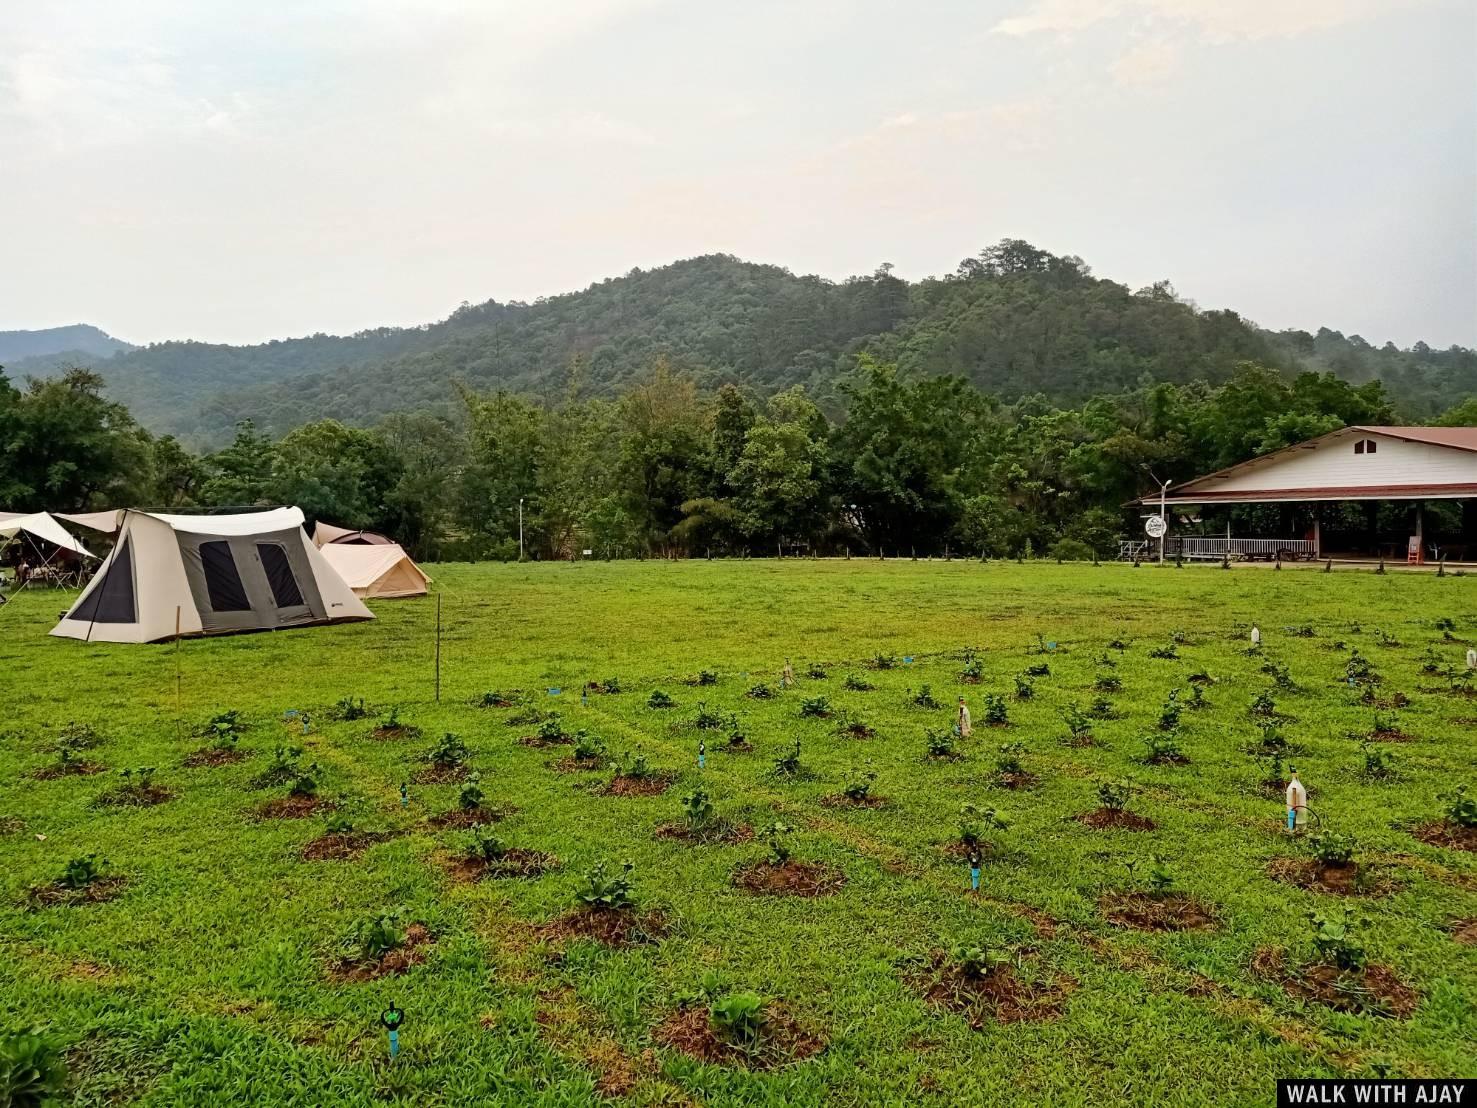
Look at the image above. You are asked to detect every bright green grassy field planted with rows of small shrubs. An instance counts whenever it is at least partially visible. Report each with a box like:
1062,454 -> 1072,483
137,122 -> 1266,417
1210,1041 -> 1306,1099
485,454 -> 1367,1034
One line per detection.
0,560 -> 1477,1105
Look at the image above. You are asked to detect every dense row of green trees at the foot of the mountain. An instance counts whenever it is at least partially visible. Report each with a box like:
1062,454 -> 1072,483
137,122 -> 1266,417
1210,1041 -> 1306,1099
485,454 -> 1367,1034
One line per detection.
0,353 -> 1477,560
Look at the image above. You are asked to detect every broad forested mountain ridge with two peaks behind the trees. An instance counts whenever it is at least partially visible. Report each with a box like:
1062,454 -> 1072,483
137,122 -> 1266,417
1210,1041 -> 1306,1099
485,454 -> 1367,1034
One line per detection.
9,239 -> 1477,445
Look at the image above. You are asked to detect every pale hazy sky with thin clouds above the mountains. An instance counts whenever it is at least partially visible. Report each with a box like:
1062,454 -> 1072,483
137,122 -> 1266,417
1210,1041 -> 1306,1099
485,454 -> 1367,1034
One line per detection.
0,0 -> 1477,346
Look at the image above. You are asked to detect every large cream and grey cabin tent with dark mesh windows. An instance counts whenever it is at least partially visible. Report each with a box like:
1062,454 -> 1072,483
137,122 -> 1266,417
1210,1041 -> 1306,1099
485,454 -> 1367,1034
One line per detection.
52,508 -> 374,643
